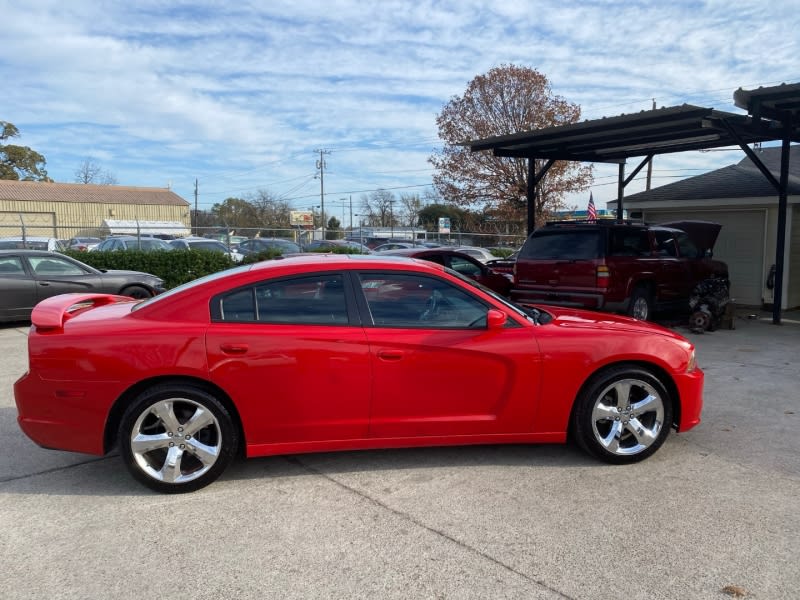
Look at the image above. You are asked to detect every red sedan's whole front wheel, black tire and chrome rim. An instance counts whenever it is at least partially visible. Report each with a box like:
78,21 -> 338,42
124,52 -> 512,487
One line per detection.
572,365 -> 672,464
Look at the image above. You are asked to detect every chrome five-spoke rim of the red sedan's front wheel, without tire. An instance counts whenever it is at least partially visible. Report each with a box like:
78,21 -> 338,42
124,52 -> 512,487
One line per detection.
591,379 -> 664,456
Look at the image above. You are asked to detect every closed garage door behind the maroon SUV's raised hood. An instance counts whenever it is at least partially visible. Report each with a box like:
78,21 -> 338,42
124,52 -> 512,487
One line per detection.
644,210 -> 766,306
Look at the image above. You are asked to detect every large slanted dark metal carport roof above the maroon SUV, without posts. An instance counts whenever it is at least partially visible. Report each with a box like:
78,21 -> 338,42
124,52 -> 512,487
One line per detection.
466,104 -> 800,163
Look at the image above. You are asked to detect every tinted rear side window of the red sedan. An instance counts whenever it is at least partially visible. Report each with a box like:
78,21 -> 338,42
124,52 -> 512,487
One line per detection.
212,274 -> 349,325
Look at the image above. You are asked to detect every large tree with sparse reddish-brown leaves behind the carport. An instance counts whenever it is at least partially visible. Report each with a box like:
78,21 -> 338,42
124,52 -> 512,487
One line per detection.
429,65 -> 592,227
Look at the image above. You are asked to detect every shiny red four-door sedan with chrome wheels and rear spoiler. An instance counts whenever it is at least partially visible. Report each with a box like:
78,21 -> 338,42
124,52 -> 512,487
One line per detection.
14,255 -> 703,492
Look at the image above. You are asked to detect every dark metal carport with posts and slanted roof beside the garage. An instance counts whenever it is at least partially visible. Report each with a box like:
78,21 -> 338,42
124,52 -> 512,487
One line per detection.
466,83 -> 800,324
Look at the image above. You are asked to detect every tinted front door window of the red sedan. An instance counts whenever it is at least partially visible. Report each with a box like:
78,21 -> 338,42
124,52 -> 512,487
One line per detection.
360,273 -> 487,329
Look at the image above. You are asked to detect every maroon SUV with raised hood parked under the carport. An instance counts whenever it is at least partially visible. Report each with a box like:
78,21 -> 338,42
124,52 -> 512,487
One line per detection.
511,220 -> 728,320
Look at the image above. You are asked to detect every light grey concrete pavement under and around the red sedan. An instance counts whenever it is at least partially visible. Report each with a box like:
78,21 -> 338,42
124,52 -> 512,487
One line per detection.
0,312 -> 800,600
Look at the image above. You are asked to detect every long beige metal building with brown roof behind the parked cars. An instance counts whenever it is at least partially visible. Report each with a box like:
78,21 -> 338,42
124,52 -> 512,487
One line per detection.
0,180 -> 191,239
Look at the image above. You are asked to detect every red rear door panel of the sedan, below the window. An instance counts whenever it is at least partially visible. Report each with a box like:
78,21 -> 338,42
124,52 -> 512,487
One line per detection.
207,323 -> 370,444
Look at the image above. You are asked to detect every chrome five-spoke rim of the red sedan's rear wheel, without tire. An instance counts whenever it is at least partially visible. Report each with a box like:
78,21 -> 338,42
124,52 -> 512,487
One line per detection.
129,398 -> 222,484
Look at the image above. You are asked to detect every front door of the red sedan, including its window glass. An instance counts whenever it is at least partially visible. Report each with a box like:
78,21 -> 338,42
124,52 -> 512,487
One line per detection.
360,272 -> 540,437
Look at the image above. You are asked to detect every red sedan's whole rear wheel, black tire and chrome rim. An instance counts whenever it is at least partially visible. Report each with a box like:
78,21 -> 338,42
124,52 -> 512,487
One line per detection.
118,384 -> 239,494
